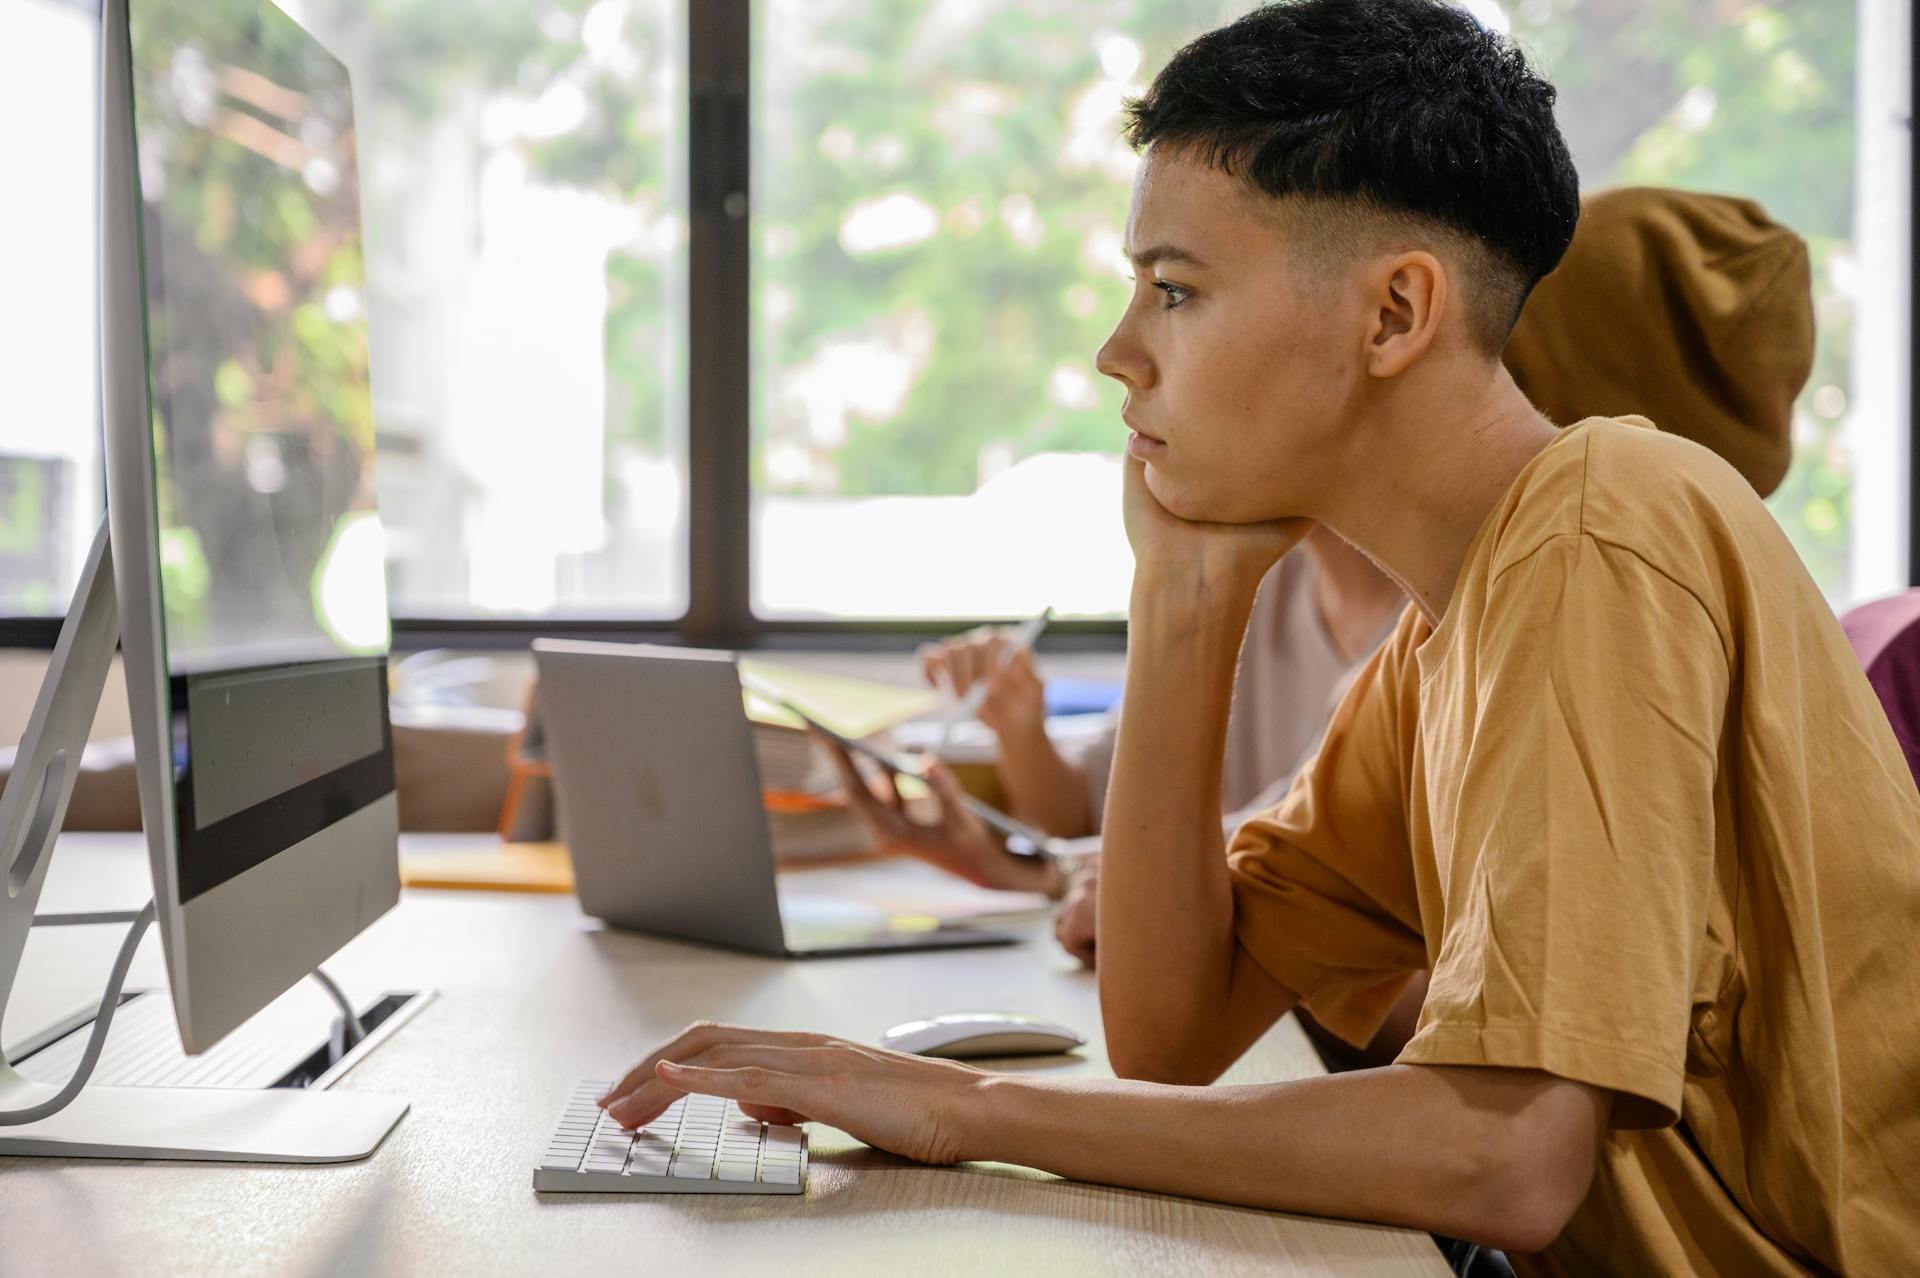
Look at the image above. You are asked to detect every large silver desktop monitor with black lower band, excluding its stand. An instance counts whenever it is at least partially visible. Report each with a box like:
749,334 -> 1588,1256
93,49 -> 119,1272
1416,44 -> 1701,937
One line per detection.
102,0 -> 399,1052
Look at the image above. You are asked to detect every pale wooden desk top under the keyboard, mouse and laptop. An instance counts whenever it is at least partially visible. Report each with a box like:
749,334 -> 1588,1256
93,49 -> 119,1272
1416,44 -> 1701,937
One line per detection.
0,835 -> 1448,1278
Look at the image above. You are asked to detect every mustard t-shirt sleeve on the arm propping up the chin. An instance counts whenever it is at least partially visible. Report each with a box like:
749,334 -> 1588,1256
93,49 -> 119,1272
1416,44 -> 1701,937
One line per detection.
1227,610 -> 1427,1044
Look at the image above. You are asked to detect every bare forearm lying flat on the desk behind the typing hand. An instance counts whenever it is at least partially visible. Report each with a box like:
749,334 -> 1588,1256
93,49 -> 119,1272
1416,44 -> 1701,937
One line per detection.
962,1065 -> 1607,1251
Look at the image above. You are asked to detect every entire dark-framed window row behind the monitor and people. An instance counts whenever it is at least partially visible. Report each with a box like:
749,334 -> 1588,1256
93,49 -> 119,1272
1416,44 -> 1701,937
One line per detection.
0,0 -> 1920,643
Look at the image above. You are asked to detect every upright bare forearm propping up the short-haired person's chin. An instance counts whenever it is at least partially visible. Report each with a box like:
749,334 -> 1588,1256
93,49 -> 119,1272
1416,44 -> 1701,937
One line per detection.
1098,574 -> 1258,1082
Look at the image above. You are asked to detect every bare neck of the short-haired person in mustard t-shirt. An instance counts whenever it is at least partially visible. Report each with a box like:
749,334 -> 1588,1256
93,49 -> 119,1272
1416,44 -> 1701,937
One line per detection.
1319,365 -> 1557,626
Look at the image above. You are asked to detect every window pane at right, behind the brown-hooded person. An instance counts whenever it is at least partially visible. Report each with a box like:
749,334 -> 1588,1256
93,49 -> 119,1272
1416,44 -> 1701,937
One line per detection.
1505,0 -> 1912,604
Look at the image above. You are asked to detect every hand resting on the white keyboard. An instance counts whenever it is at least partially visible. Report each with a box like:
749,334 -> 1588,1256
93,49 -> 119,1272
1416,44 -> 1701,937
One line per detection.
601,1023 -> 993,1163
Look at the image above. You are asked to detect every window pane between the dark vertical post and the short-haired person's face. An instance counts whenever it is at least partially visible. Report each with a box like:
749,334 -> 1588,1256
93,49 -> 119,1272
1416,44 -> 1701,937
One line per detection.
753,0 -> 1240,618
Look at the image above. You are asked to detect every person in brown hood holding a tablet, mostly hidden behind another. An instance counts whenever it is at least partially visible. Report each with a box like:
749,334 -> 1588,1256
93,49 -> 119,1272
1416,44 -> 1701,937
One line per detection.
871,186 -> 1814,970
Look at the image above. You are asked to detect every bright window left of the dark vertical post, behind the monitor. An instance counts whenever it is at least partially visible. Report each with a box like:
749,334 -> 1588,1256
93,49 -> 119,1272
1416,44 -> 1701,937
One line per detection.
0,0 -> 687,620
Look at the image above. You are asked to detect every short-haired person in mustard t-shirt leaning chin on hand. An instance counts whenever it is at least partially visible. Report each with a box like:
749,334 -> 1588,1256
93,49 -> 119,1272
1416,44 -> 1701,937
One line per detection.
607,0 -> 1920,1274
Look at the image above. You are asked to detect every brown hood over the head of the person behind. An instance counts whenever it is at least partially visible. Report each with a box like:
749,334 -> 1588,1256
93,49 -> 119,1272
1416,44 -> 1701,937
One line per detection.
1503,186 -> 1812,497
